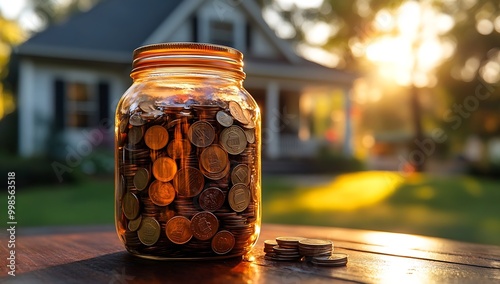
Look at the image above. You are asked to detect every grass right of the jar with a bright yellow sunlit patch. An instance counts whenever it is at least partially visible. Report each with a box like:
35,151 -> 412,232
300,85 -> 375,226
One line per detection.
263,172 -> 500,245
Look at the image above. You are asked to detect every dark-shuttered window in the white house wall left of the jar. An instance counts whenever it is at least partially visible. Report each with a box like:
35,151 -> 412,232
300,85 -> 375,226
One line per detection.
55,79 -> 109,130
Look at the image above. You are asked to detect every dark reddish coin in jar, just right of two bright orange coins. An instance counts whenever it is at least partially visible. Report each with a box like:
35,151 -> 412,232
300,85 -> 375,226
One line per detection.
173,167 -> 205,197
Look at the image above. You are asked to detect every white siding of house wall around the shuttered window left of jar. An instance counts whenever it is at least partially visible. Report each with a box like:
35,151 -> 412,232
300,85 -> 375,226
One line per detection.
19,60 -> 130,156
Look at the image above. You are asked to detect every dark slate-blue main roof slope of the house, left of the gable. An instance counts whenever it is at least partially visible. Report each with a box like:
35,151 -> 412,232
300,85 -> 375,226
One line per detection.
17,0 -> 182,63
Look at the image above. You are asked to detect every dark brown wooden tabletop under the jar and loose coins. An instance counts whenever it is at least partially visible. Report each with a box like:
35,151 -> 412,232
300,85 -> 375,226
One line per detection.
0,224 -> 500,284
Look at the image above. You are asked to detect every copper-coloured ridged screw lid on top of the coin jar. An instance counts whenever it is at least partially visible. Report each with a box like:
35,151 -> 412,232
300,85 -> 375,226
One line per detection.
131,42 -> 245,77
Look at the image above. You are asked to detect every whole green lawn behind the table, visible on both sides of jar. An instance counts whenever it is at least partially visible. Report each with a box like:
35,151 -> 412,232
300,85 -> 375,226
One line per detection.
5,172 -> 500,245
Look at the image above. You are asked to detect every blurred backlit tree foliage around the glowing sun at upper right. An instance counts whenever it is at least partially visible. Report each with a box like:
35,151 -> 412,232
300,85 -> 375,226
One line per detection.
264,0 -> 500,170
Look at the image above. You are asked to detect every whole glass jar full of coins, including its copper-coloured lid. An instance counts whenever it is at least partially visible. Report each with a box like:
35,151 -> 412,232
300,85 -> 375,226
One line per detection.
115,43 -> 261,259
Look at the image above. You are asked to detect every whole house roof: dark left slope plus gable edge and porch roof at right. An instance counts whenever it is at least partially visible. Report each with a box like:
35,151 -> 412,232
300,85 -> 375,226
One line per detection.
17,0 -> 356,84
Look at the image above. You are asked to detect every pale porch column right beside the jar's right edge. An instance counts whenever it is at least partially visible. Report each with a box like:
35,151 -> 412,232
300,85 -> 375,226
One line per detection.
262,81 -> 280,159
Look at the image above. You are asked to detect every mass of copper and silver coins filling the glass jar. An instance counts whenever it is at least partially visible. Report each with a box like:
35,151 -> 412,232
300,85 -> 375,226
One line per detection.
116,100 -> 260,258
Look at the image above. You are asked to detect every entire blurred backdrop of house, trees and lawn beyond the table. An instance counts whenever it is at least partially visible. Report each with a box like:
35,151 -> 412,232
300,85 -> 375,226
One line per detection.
0,0 -> 500,245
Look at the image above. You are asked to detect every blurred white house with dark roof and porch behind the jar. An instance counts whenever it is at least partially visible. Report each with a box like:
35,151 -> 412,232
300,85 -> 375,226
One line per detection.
16,0 -> 355,159
